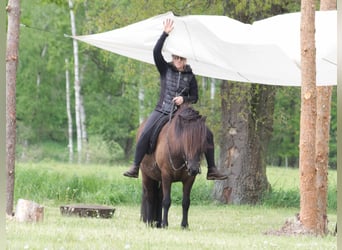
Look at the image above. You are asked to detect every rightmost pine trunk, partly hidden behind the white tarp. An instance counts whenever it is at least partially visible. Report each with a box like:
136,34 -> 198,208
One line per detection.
316,0 -> 336,234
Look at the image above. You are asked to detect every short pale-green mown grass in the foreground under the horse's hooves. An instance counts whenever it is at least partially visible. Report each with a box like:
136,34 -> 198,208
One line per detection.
6,204 -> 336,250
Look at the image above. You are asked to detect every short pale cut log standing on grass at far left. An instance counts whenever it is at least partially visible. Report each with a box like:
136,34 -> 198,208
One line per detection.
14,199 -> 44,222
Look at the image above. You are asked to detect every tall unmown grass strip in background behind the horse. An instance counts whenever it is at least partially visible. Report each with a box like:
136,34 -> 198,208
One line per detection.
15,162 -> 337,212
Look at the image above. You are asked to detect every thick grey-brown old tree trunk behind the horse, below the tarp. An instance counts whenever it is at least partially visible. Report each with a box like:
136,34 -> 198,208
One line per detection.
214,81 -> 275,204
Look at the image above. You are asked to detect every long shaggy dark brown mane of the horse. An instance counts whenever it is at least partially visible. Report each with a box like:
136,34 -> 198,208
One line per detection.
173,105 -> 207,157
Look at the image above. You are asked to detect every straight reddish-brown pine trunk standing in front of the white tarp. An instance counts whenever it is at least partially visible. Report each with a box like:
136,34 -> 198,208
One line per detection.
299,0 -> 317,232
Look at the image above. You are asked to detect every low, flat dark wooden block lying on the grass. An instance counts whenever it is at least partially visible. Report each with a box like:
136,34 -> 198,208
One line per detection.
60,204 -> 115,219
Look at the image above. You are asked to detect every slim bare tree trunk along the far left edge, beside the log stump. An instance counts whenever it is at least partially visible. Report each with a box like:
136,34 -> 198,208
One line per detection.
6,0 -> 20,215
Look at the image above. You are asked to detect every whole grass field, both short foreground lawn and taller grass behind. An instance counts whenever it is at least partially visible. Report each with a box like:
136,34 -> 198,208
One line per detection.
6,163 -> 337,250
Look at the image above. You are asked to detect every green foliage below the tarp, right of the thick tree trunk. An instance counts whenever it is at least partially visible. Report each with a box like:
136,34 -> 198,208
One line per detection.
267,87 -> 337,169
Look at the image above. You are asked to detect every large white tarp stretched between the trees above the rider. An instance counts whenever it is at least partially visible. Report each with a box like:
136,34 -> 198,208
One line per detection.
74,11 -> 337,86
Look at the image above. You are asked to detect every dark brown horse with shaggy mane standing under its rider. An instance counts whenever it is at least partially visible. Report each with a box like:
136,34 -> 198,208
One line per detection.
140,105 -> 207,228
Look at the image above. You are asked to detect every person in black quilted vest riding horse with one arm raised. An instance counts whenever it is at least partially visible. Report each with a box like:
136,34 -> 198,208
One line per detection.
124,19 -> 228,180
